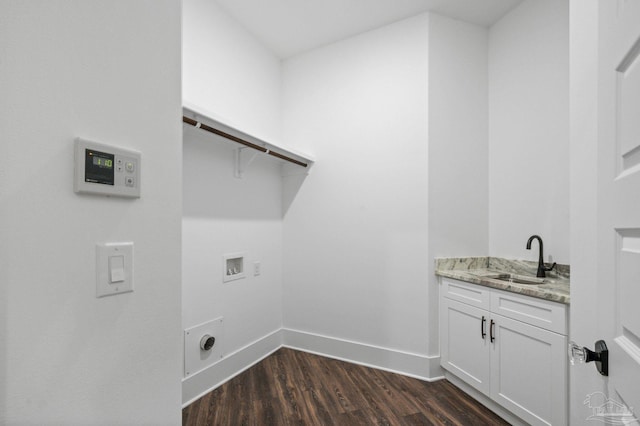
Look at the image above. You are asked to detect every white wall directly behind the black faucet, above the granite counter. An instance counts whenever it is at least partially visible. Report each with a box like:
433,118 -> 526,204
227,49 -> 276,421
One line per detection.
489,0 -> 569,263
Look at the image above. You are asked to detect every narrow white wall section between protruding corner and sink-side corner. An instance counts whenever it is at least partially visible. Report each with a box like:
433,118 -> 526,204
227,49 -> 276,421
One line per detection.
428,14 -> 489,353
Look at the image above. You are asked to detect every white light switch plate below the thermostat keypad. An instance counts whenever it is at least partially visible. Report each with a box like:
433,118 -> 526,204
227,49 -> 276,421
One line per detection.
96,243 -> 133,297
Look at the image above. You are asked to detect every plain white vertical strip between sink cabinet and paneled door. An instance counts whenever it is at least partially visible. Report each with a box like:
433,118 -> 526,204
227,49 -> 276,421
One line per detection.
569,0 -> 607,424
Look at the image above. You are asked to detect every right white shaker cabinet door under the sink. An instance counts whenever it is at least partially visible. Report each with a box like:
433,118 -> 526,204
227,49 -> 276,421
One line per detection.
491,314 -> 567,426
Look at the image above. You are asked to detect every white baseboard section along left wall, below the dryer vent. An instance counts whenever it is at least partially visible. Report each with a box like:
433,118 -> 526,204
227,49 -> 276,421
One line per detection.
182,329 -> 282,408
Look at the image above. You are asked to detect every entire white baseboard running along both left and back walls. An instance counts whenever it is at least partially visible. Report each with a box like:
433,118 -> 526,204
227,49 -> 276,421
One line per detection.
182,328 -> 444,408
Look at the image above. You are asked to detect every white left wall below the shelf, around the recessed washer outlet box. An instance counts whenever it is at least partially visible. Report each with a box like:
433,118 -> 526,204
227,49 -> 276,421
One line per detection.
182,129 -> 282,342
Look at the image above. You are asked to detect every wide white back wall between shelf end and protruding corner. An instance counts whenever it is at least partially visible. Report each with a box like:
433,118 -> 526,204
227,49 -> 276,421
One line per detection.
283,14 -> 431,372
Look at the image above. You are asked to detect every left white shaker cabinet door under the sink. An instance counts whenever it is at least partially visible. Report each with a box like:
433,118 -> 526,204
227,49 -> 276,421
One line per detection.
440,298 -> 491,394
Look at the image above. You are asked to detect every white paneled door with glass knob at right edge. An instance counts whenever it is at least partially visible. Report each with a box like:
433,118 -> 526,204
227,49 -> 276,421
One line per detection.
597,0 -> 640,424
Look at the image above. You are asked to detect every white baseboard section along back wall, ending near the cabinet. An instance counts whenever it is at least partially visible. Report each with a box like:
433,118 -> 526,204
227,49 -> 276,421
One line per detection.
282,328 -> 444,382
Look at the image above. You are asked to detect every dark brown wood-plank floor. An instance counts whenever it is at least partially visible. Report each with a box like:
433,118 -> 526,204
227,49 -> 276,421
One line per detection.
182,348 -> 508,426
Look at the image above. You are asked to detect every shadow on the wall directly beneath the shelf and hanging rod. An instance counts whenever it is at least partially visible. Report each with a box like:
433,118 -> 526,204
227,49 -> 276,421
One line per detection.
182,126 -> 306,220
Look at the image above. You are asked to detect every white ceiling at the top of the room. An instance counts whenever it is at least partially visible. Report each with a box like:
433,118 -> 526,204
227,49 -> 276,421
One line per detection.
216,0 -> 523,58
